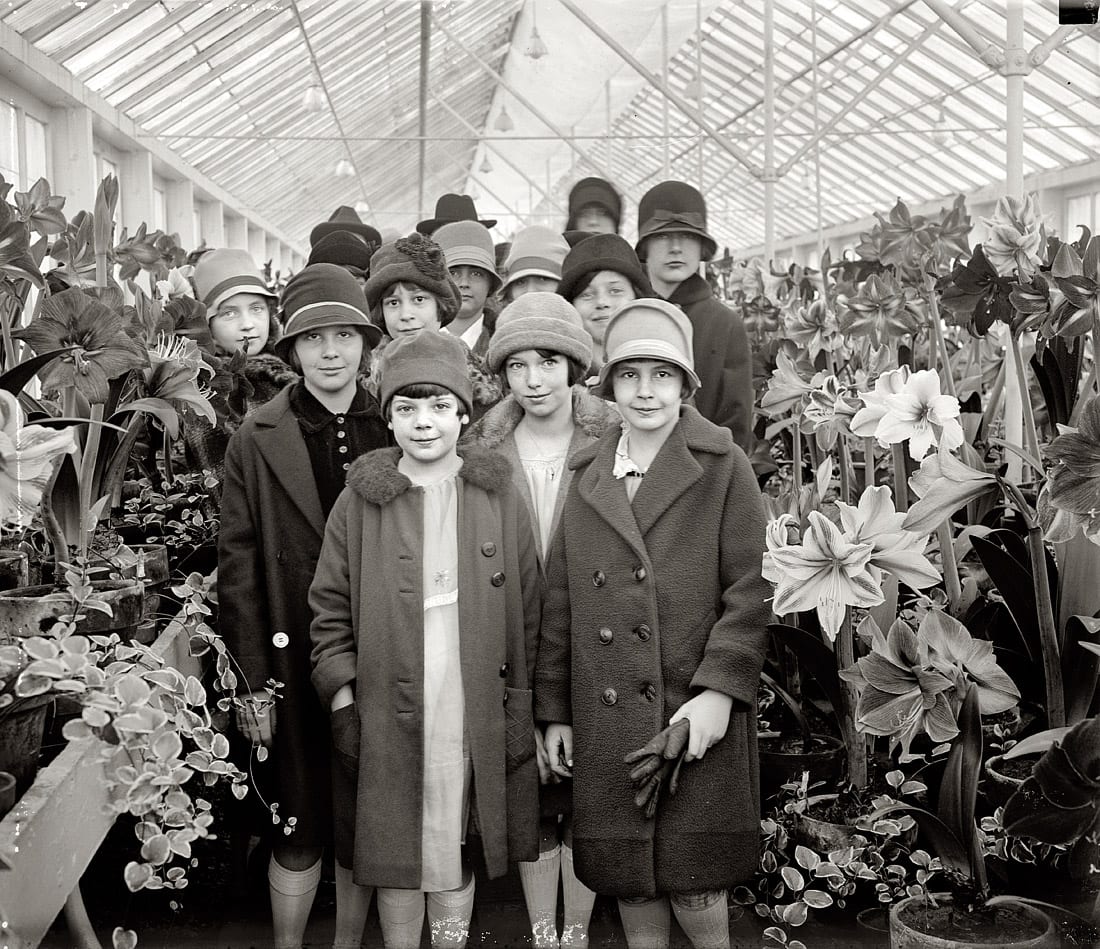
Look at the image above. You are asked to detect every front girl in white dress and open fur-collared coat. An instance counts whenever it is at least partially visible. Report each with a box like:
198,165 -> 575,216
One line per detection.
309,332 -> 539,949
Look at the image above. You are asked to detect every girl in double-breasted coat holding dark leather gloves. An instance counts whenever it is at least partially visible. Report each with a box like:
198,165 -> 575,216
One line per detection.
535,299 -> 771,949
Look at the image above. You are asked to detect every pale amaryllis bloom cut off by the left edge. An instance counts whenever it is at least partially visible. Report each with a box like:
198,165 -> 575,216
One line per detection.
0,389 -> 76,527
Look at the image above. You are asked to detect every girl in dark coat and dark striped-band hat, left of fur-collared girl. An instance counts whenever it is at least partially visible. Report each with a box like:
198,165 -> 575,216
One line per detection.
218,264 -> 387,949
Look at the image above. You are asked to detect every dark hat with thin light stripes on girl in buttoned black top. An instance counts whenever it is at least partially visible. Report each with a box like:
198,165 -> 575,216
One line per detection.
275,264 -> 382,363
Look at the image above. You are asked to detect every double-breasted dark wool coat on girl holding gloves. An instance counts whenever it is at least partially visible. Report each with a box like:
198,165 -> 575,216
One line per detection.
535,406 -> 771,897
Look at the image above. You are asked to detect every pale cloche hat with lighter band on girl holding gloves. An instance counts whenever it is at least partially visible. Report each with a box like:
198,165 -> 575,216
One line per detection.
596,298 -> 702,398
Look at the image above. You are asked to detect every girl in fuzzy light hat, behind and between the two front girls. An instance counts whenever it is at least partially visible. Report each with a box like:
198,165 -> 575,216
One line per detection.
468,291 -> 619,949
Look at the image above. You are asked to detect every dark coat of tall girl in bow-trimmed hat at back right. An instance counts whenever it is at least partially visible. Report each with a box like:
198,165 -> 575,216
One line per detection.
669,274 -> 752,451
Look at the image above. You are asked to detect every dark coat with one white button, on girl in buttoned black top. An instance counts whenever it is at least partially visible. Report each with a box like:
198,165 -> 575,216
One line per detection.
218,389 -> 388,847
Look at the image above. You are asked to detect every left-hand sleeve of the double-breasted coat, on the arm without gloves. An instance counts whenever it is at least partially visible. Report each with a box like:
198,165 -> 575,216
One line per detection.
535,523 -> 573,724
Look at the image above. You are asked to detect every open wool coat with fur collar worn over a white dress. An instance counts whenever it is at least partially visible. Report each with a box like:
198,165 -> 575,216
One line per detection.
309,446 -> 539,890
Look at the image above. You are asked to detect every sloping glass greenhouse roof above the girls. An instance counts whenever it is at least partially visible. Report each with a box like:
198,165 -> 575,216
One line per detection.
0,0 -> 1100,253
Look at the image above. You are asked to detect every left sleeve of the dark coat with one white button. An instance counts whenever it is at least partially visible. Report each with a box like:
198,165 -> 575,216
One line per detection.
218,432 -> 273,692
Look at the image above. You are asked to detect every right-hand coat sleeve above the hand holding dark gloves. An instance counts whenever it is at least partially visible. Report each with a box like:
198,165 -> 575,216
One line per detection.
691,448 -> 772,707
